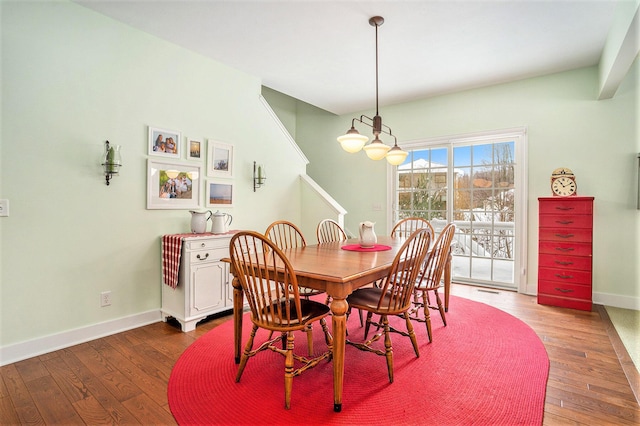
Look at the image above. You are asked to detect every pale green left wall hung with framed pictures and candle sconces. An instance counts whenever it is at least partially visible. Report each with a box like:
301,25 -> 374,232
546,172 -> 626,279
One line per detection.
0,1 -> 306,354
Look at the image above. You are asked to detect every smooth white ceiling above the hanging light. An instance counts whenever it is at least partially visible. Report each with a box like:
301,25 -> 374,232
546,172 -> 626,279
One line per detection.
75,0 -> 616,114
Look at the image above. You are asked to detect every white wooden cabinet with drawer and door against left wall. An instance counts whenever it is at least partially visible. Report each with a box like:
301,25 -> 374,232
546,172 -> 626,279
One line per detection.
161,234 -> 233,331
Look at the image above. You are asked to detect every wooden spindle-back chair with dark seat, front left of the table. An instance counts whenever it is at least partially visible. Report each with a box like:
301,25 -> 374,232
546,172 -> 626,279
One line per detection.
230,231 -> 333,409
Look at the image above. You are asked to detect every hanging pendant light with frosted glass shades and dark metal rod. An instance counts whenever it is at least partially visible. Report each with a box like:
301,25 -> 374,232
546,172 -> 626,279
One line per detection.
338,16 -> 408,166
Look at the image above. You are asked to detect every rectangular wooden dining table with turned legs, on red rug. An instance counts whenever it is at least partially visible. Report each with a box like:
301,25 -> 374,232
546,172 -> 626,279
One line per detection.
231,236 -> 448,412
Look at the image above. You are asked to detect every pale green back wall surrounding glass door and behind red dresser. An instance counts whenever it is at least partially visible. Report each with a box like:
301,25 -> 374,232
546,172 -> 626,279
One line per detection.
286,60 -> 640,309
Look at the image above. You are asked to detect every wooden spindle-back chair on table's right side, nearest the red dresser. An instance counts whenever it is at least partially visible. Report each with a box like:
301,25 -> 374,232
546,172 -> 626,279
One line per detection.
409,223 -> 456,342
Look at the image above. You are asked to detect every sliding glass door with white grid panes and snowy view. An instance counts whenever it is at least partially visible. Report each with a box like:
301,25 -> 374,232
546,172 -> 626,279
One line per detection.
392,129 -> 526,289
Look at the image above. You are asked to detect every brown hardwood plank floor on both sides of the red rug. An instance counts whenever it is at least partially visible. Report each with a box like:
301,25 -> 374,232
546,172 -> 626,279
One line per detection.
0,285 -> 640,425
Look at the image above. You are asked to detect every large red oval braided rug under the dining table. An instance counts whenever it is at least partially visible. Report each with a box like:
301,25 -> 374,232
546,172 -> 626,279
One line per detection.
168,296 -> 549,425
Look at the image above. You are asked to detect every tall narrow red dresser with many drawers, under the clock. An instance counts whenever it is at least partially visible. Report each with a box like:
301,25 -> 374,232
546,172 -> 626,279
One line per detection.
538,197 -> 594,311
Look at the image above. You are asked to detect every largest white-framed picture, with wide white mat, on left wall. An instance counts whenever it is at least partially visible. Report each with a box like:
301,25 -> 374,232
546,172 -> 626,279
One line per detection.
147,159 -> 202,209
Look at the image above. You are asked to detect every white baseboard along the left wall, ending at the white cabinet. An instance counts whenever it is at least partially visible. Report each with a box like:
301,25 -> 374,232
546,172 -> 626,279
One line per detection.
0,309 -> 162,366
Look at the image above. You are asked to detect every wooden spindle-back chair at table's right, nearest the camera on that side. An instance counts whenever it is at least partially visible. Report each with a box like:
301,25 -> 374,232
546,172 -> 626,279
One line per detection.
347,228 -> 431,383
